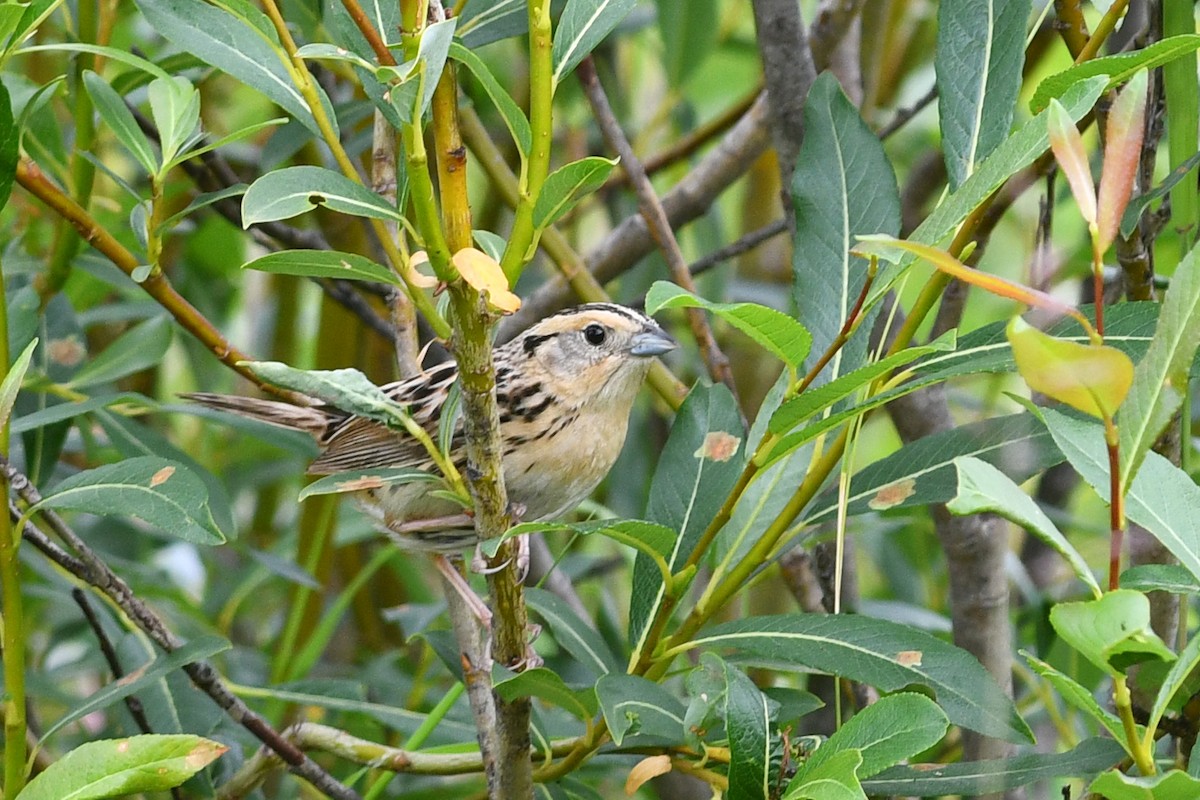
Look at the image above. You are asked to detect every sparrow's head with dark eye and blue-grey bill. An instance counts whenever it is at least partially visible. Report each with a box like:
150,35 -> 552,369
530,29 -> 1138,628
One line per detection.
505,303 -> 677,405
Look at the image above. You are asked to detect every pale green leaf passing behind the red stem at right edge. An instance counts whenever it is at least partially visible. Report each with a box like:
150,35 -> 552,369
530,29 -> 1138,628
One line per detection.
1040,408 -> 1200,578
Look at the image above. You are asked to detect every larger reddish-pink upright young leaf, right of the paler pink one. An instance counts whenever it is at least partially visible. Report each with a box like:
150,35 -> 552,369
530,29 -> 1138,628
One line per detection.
1096,70 -> 1147,253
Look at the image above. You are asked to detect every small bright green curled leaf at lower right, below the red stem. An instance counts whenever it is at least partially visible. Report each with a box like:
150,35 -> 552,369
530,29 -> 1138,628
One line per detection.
1050,589 -> 1175,678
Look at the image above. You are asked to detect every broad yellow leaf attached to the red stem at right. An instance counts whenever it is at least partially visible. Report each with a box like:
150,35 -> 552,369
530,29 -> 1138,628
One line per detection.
1007,317 -> 1133,419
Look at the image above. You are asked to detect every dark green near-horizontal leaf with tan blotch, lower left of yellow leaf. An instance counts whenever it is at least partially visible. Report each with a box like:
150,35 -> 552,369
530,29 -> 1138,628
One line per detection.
805,414 -> 1063,524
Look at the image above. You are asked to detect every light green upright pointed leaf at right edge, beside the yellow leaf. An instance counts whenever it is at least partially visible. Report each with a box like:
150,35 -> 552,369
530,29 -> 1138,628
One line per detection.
1117,242 -> 1200,491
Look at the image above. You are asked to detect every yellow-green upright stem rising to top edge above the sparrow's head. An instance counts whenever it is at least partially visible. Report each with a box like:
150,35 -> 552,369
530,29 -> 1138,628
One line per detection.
500,0 -> 554,285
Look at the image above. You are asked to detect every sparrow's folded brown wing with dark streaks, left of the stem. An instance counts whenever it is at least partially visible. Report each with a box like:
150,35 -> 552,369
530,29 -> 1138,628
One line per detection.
308,361 -> 461,475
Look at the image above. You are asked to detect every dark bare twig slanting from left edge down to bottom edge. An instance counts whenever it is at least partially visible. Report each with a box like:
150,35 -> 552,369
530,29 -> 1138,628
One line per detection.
0,457 -> 361,800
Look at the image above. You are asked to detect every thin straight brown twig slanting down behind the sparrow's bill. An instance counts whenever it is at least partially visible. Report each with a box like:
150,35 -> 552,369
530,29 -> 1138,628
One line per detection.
575,56 -> 738,410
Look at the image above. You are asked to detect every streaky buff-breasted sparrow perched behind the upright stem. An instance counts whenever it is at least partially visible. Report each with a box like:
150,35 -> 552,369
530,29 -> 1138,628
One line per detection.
187,303 -> 676,553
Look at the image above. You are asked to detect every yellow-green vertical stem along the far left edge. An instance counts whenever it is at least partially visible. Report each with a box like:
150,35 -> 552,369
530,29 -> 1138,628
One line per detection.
0,248 -> 25,798
